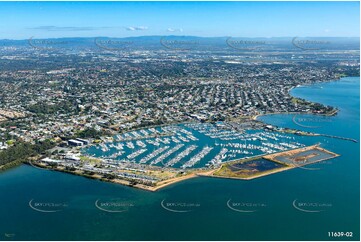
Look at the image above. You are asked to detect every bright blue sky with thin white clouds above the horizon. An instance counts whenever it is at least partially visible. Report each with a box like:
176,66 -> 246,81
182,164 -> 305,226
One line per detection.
0,2 -> 360,39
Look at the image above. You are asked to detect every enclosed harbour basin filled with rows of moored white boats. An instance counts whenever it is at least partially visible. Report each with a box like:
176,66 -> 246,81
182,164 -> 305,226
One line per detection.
82,122 -> 304,169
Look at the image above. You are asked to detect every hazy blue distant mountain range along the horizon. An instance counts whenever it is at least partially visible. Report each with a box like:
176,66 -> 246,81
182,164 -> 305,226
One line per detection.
0,35 -> 360,50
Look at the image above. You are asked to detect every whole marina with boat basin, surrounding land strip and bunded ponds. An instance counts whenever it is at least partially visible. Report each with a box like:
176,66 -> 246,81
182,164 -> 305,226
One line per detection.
24,119 -> 337,191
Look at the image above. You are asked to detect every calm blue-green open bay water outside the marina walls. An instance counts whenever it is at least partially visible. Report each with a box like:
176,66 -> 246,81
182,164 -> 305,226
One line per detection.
0,78 -> 360,240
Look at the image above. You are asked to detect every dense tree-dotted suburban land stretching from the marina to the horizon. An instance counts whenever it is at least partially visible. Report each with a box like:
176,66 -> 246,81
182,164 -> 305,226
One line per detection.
0,37 -> 359,189
